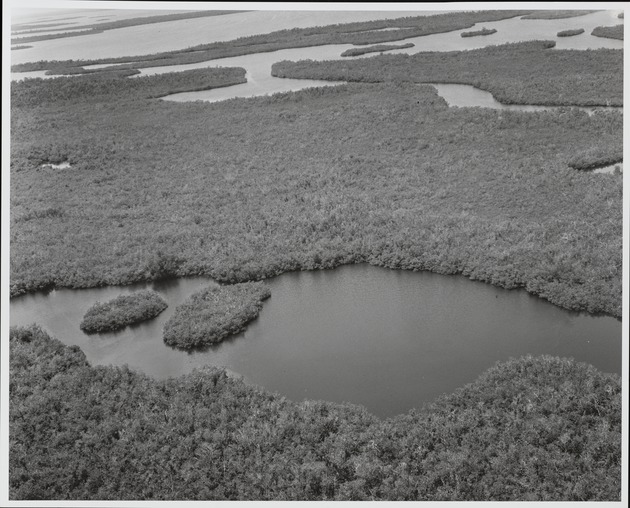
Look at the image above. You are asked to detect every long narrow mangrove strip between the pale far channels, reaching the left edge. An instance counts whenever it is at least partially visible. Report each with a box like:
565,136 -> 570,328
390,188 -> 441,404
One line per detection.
11,11 -> 531,74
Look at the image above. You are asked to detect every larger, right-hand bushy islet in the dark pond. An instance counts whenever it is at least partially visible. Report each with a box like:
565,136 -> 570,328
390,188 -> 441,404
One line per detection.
164,282 -> 271,349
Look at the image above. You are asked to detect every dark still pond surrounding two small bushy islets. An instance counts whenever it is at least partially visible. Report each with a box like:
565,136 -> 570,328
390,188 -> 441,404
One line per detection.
10,265 -> 621,416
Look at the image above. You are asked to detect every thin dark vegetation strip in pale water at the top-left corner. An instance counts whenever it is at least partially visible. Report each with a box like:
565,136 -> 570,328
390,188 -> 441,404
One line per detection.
11,11 -> 247,44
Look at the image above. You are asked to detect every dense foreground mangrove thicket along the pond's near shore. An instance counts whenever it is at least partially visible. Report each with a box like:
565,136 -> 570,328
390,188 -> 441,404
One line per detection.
9,328 -> 621,501
